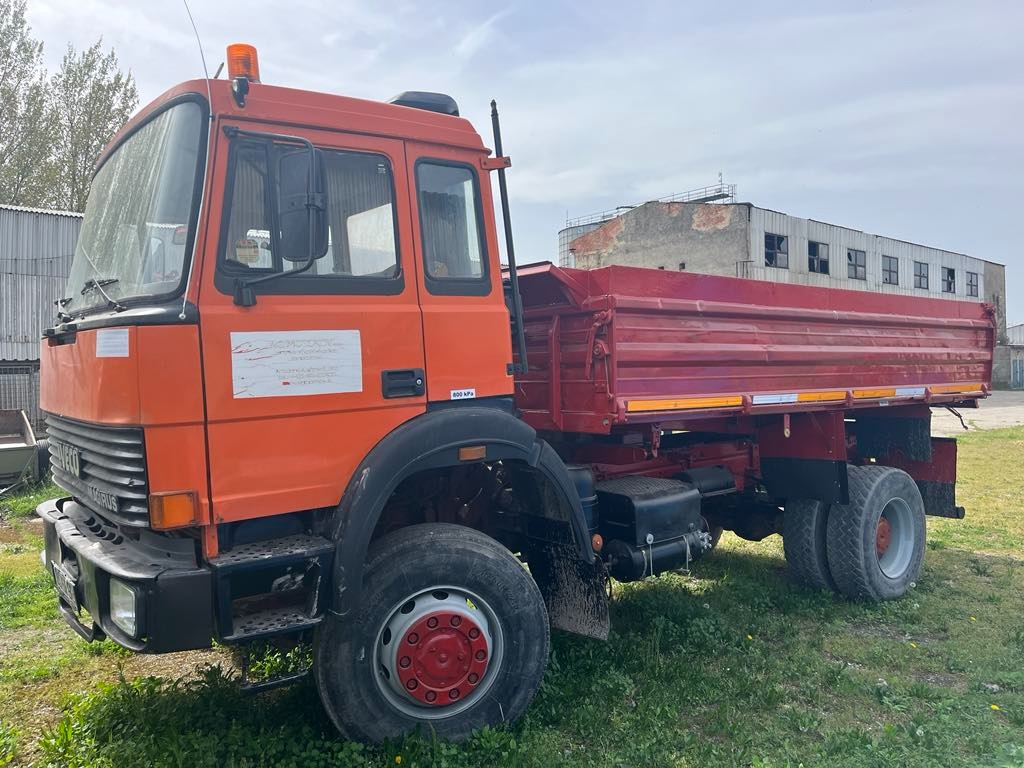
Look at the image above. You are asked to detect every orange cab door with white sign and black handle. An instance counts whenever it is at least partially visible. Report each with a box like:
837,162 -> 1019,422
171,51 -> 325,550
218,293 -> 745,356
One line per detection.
201,124 -> 426,522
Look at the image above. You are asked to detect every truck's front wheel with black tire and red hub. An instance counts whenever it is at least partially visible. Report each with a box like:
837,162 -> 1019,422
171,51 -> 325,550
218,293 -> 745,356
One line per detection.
314,523 -> 550,742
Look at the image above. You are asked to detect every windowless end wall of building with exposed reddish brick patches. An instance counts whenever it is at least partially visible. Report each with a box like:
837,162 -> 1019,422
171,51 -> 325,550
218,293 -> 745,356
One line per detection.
569,203 -> 750,276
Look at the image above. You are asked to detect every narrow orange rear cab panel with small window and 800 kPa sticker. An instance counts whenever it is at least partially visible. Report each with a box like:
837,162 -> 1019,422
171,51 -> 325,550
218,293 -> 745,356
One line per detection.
407,141 -> 513,402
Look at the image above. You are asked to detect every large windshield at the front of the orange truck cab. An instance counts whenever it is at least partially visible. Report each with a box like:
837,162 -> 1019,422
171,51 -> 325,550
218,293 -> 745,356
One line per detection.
63,101 -> 204,312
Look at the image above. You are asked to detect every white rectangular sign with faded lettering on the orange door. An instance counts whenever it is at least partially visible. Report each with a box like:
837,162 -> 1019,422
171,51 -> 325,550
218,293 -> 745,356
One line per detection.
231,331 -> 362,398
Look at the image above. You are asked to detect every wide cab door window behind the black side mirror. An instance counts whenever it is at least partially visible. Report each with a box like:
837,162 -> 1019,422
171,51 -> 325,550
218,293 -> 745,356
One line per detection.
222,141 -> 401,293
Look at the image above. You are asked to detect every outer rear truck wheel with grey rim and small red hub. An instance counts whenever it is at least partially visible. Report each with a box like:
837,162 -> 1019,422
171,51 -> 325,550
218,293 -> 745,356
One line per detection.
828,465 -> 925,601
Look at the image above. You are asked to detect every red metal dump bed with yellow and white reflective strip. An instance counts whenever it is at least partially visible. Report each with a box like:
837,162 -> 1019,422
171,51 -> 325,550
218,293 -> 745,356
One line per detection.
516,264 -> 995,433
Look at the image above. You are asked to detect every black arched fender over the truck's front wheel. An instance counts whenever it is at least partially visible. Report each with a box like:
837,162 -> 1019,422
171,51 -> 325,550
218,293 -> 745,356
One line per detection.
326,404 -> 594,615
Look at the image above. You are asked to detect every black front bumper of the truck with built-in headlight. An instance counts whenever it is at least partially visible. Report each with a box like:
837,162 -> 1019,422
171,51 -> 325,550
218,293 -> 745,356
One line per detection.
36,499 -> 213,653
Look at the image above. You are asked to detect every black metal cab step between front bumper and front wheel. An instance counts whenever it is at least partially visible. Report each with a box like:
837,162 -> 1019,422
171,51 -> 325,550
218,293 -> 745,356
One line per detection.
210,534 -> 335,643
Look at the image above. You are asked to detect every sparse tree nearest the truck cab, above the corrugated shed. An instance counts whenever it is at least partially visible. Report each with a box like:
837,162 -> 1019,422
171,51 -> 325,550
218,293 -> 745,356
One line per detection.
47,39 -> 138,211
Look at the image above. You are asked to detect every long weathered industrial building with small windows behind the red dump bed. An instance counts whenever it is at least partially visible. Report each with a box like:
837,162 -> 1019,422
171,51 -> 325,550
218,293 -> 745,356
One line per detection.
559,184 -> 1011,388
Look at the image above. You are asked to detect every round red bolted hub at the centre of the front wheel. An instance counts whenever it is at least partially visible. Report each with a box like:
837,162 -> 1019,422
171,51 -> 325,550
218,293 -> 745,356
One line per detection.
395,610 -> 489,707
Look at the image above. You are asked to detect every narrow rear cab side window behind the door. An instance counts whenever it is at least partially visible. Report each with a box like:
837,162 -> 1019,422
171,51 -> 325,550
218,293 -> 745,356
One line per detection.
416,161 -> 490,295
